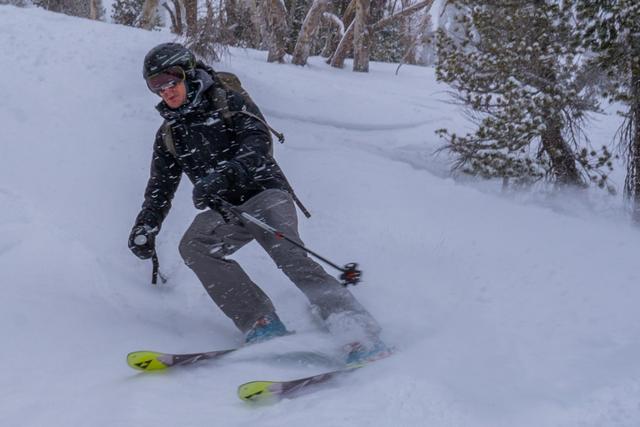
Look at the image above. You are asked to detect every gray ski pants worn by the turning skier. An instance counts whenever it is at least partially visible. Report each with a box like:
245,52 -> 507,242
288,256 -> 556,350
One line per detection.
180,189 -> 380,339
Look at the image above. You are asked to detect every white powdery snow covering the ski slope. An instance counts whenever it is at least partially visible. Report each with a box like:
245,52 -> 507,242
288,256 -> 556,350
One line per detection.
0,6 -> 640,427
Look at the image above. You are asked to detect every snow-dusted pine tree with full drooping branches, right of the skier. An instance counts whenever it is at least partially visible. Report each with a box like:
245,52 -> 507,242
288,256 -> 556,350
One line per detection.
436,0 -> 611,186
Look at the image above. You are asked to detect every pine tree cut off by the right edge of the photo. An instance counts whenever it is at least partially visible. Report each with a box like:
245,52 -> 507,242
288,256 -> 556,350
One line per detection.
577,4 -> 640,223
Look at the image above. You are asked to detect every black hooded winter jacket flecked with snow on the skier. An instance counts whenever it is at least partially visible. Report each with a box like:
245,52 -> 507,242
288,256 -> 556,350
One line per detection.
136,69 -> 290,231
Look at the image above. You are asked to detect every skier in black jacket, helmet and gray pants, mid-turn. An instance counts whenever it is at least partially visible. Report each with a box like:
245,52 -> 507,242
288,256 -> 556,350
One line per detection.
129,43 -> 389,363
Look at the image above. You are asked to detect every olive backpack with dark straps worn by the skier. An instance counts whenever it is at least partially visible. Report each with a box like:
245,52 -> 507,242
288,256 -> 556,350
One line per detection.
161,71 -> 311,218
